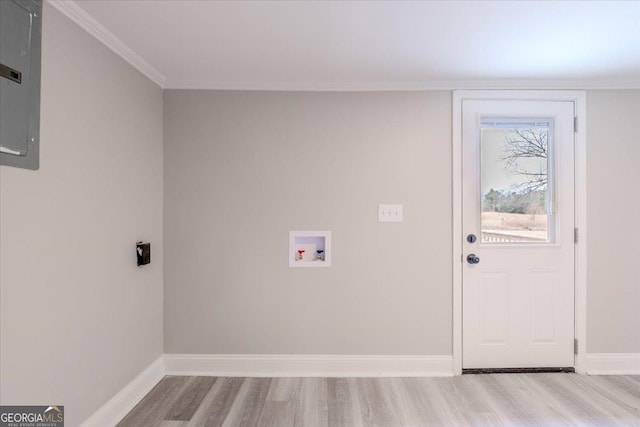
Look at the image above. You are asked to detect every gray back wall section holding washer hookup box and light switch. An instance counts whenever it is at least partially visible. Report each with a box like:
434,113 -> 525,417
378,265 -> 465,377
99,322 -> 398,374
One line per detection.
164,90 -> 452,355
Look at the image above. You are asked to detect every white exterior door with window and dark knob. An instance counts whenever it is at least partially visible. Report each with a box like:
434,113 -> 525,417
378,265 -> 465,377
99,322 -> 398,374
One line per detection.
462,100 -> 574,369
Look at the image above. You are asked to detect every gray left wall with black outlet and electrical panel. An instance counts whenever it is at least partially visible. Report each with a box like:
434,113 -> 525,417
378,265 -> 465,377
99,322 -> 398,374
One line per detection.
0,2 -> 163,427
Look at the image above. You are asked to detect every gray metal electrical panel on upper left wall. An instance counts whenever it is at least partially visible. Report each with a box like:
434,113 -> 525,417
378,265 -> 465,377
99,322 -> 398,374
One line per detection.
0,0 -> 42,169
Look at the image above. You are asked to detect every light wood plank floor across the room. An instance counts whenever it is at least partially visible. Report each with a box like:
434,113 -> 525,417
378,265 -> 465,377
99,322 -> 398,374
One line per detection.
118,373 -> 640,427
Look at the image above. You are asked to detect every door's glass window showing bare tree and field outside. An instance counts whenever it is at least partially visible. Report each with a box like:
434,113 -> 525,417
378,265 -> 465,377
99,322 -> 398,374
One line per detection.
480,119 -> 554,243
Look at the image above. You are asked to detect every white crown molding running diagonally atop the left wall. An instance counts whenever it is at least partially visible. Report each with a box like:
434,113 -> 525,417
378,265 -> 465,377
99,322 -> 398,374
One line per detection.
48,0 -> 166,88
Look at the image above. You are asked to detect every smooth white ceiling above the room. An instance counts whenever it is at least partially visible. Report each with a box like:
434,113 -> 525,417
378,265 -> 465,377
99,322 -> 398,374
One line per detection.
51,0 -> 640,90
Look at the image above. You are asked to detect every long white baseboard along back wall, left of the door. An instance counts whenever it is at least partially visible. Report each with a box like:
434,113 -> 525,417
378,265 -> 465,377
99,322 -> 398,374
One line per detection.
165,354 -> 453,377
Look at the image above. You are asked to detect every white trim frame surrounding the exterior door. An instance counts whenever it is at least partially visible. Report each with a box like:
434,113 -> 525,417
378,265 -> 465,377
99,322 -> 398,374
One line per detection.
452,90 -> 587,375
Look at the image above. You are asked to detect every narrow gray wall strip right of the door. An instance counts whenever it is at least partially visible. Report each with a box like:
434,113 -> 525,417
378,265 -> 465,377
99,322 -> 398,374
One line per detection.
587,90 -> 640,353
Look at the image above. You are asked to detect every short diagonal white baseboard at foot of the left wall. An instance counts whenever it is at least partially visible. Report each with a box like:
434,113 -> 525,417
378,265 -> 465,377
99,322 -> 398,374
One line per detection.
81,356 -> 165,427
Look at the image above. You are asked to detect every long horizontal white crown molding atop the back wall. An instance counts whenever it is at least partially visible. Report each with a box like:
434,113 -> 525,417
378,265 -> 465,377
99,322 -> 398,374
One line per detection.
165,79 -> 640,92
